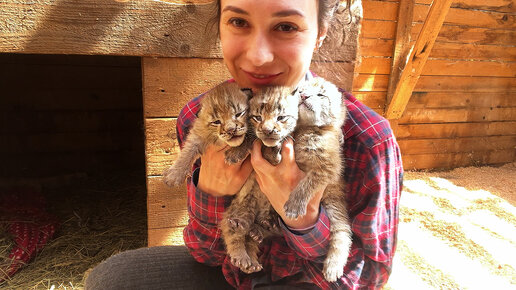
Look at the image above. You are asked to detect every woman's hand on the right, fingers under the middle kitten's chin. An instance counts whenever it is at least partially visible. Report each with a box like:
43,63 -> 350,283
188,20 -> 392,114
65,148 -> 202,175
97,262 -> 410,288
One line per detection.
251,139 -> 325,229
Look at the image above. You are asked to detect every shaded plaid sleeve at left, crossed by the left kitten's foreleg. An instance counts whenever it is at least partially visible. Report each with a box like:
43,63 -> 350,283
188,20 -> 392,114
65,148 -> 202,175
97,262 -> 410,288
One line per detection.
176,95 -> 232,266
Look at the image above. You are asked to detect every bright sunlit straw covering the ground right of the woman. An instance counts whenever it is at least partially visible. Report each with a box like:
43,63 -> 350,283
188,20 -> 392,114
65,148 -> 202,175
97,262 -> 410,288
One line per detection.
386,163 -> 516,289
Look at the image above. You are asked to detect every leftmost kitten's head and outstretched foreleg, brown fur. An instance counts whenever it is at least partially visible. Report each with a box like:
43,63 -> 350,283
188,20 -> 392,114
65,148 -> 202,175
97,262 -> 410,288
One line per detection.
163,82 -> 251,186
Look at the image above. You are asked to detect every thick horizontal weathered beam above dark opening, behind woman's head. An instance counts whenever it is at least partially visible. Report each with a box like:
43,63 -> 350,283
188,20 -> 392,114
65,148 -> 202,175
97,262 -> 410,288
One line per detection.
0,0 -> 361,61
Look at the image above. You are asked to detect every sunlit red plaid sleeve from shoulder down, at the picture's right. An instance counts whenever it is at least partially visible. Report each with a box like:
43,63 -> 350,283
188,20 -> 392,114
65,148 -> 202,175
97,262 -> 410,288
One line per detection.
340,96 -> 403,289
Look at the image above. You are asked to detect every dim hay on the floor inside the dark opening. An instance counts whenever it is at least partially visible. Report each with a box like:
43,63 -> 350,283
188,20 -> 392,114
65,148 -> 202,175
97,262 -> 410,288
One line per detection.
0,172 -> 147,289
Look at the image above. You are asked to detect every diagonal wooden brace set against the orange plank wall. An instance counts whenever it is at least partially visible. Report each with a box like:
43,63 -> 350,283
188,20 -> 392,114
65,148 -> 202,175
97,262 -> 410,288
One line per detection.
385,0 -> 452,119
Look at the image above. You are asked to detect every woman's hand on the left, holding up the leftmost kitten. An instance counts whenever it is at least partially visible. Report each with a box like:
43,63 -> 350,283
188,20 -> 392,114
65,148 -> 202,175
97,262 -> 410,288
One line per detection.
197,145 -> 253,196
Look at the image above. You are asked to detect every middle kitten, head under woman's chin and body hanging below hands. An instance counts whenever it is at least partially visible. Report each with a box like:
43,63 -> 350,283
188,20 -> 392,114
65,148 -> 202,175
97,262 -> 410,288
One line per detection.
220,87 -> 299,273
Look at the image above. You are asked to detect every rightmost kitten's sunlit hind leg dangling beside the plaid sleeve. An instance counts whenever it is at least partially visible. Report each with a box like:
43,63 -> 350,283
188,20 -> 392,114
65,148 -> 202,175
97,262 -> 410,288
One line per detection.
322,185 -> 352,282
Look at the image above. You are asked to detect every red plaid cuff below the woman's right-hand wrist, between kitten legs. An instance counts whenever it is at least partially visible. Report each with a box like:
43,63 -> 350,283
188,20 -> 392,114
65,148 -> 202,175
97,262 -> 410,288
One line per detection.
280,206 -> 330,262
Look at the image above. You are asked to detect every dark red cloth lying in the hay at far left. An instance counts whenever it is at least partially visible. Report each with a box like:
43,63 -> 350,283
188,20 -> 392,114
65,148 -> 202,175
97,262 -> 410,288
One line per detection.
0,187 -> 59,282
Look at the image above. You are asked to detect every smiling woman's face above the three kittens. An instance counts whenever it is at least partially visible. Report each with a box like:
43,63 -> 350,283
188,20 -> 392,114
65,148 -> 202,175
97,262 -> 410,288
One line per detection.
219,0 -> 324,90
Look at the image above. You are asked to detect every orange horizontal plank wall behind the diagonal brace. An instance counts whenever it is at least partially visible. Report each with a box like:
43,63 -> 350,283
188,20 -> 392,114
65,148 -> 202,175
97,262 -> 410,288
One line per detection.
353,0 -> 516,169
